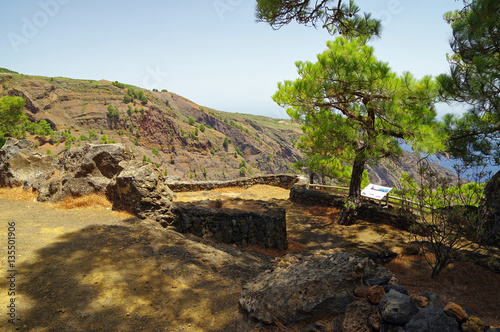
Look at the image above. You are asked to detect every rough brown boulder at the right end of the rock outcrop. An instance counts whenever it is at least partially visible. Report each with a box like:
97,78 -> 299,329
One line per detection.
110,160 -> 174,226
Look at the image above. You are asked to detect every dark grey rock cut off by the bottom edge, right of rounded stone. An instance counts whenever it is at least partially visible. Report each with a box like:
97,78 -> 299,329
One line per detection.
405,307 -> 460,332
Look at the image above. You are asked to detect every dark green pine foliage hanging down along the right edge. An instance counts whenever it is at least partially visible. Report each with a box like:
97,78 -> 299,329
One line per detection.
437,0 -> 500,165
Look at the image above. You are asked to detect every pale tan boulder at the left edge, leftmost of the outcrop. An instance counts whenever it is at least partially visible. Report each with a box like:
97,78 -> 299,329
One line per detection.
0,138 -> 57,187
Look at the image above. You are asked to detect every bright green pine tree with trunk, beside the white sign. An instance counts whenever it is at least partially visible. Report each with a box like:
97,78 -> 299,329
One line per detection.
273,37 -> 446,222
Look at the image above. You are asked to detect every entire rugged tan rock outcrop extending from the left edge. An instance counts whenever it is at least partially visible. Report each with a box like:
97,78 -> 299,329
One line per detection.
0,139 -> 174,224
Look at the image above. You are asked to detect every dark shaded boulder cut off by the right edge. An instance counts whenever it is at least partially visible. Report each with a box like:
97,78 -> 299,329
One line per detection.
479,171 -> 500,244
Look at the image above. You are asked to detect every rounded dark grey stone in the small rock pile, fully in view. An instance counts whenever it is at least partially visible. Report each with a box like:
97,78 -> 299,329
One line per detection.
379,289 -> 418,326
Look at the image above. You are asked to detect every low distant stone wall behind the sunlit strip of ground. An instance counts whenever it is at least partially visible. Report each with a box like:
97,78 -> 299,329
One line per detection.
166,174 -> 300,192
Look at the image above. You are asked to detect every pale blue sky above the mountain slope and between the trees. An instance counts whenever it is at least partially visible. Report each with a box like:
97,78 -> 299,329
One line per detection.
0,0 -> 462,118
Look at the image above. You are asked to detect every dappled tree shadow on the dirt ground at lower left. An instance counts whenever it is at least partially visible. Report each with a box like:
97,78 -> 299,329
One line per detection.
6,219 -> 274,331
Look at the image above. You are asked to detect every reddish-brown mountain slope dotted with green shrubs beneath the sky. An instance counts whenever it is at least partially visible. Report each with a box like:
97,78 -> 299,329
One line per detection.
0,72 -> 452,186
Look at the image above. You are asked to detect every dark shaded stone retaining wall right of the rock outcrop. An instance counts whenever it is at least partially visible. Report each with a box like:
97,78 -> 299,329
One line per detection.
172,202 -> 288,250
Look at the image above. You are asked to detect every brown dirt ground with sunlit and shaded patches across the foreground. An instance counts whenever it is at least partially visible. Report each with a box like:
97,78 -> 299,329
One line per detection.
0,186 -> 500,331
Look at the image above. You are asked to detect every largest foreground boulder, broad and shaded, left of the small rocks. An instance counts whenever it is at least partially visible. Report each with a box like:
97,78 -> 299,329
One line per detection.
240,252 -> 392,323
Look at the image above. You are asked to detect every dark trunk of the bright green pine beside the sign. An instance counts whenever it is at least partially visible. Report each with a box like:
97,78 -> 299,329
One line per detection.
338,153 -> 367,225
